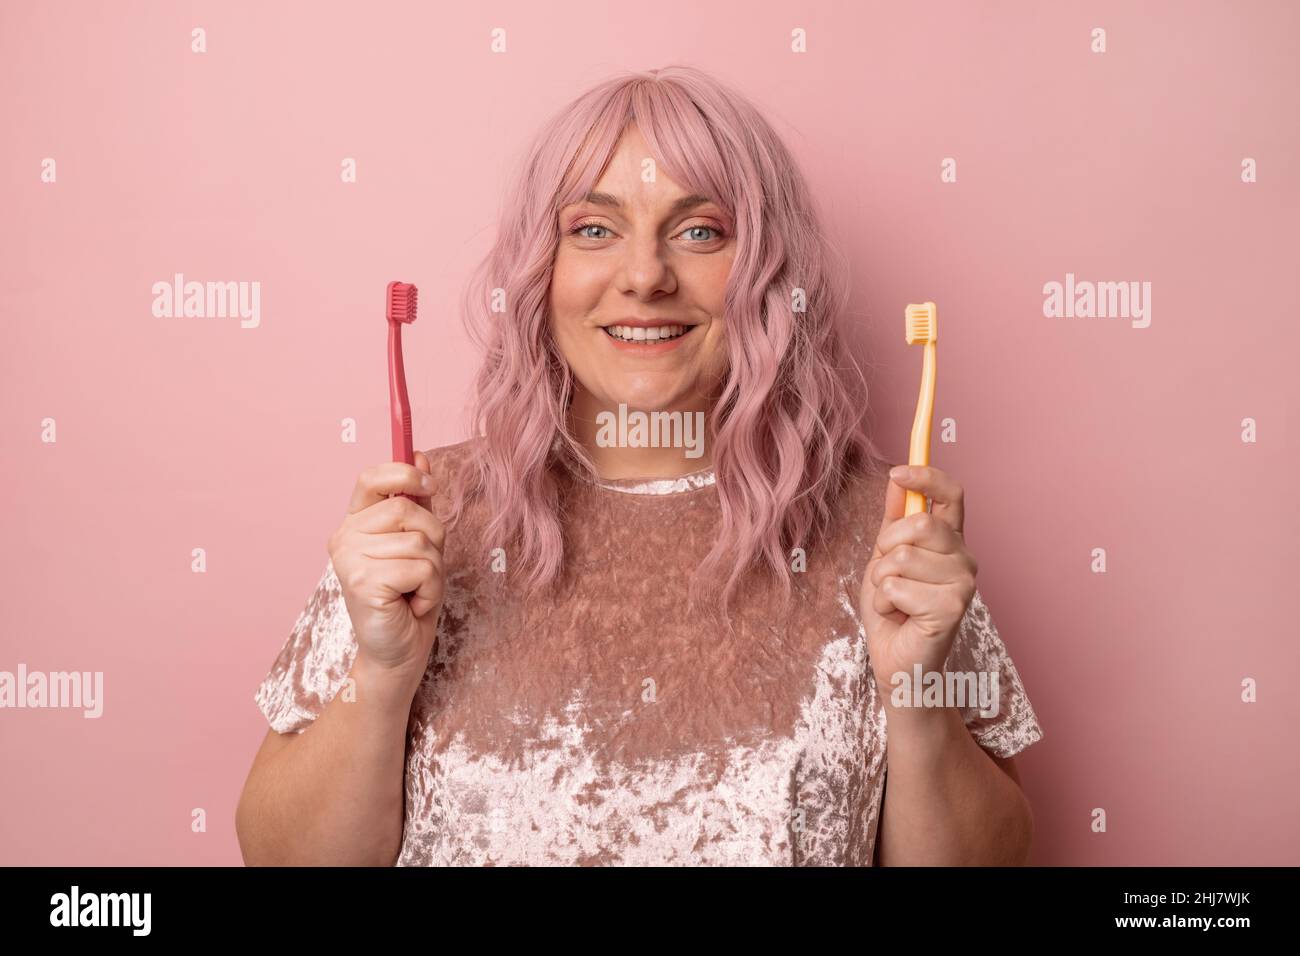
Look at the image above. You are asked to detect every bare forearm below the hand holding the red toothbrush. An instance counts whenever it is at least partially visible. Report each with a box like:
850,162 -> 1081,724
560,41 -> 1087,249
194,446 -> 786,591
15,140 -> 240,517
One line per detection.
237,659 -> 415,866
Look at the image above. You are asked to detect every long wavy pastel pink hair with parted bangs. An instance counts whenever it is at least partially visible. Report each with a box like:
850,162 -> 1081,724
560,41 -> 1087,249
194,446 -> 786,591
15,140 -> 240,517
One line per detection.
450,66 -> 881,615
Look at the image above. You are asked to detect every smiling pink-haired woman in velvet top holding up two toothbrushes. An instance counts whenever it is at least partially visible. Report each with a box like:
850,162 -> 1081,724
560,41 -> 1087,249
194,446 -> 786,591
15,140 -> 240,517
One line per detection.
237,61 -> 1041,866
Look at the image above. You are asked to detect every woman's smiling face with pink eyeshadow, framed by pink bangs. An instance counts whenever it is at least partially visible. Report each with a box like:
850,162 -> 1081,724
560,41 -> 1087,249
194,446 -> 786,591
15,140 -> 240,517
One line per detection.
549,126 -> 736,431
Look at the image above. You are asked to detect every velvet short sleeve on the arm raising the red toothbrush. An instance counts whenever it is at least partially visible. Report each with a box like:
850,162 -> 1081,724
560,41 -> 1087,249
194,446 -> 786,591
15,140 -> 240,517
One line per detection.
254,562 -> 356,734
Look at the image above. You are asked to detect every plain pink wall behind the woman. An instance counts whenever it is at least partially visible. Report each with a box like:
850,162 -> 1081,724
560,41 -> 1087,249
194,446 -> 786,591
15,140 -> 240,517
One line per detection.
0,0 -> 1300,865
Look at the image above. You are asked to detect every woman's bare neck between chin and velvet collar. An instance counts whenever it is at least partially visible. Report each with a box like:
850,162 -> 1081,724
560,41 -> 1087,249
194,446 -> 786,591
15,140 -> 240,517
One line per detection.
568,392 -> 714,479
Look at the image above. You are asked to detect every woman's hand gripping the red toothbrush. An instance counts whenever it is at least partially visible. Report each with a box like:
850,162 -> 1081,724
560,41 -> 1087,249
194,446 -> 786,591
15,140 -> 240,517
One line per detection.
328,451 -> 446,689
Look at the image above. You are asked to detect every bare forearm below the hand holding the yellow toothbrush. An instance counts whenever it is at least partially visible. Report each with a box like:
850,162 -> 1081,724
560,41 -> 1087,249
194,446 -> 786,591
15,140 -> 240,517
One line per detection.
878,689 -> 1034,866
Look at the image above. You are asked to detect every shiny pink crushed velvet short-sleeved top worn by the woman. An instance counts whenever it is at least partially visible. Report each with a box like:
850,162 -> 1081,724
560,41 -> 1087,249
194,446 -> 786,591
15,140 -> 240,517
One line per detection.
256,444 -> 1043,866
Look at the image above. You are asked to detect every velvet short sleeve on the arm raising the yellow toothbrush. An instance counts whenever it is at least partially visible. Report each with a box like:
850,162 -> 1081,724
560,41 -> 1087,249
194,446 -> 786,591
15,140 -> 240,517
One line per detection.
945,591 -> 1043,757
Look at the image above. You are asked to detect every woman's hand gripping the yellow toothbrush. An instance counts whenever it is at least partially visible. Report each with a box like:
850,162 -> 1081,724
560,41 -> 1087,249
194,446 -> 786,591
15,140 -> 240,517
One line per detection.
859,466 -> 979,689
